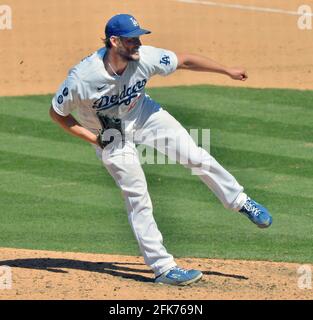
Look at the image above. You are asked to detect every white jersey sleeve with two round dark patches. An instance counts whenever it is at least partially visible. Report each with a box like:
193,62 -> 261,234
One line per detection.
52,75 -> 80,117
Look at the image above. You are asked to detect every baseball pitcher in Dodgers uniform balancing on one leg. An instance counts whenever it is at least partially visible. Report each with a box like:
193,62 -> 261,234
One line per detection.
50,14 -> 272,285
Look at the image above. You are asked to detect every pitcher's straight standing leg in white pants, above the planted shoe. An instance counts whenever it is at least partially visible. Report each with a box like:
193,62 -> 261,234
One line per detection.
102,145 -> 176,276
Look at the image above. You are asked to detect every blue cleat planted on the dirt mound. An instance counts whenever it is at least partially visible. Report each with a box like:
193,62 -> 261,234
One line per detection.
154,266 -> 202,286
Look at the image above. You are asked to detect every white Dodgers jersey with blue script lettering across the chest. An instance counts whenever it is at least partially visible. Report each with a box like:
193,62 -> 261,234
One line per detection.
52,46 -> 177,133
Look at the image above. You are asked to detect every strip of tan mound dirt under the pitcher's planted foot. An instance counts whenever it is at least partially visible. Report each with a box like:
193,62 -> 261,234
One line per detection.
0,248 -> 313,300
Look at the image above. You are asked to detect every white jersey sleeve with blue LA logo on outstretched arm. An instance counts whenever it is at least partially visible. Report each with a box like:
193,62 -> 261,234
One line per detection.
141,47 -> 178,76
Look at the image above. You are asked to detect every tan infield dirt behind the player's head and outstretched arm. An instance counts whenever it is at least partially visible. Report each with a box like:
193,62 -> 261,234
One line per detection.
0,0 -> 313,96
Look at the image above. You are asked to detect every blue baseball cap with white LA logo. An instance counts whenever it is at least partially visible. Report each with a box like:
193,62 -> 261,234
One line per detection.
105,14 -> 151,38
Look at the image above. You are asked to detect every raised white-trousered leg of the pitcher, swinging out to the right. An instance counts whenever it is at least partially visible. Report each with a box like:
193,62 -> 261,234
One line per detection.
139,110 -> 247,211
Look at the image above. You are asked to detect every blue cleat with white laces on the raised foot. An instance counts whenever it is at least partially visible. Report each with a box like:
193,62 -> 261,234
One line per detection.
239,198 -> 272,228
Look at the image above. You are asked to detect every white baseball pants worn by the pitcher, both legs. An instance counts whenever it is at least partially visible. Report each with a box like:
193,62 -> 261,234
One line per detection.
97,109 -> 247,276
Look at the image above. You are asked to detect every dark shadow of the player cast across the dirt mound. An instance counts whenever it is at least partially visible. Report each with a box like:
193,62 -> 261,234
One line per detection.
0,258 -> 248,283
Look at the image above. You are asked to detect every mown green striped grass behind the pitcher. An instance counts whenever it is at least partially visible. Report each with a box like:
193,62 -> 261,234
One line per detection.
0,86 -> 313,262
